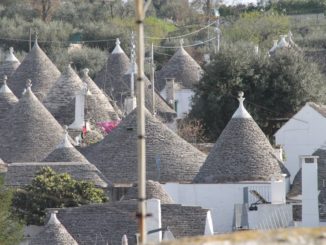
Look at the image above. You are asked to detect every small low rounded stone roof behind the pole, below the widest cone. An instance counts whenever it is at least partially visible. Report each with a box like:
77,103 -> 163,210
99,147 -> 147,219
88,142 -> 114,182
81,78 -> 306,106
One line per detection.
123,180 -> 174,204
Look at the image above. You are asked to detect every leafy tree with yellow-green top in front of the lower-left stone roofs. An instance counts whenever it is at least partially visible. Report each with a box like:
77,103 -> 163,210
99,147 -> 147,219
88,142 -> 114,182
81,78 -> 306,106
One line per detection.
13,167 -> 107,225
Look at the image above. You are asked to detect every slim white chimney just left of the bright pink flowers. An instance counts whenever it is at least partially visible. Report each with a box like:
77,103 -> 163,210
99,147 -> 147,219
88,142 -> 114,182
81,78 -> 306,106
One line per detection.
69,83 -> 88,130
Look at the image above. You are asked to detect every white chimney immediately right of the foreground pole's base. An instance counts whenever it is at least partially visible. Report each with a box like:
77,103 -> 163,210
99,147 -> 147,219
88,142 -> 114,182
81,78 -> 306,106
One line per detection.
146,198 -> 162,243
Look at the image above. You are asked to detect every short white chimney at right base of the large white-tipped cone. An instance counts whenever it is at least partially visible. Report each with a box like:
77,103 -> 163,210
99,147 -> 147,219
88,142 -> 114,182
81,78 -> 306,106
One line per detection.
271,174 -> 286,204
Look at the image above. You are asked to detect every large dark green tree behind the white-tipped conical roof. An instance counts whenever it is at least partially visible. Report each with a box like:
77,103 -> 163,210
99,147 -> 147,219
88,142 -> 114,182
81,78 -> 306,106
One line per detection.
190,47 -> 326,140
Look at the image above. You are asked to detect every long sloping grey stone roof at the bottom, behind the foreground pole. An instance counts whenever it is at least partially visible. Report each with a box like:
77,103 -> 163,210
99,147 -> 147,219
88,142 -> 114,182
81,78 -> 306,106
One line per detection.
58,200 -> 207,245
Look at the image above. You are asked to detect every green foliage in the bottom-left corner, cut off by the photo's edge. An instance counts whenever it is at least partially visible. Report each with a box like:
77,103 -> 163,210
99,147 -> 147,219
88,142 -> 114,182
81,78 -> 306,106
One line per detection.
0,176 -> 23,245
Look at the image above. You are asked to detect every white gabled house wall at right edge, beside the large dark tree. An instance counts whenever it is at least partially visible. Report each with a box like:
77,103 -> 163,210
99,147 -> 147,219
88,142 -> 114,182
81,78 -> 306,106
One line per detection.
275,105 -> 326,182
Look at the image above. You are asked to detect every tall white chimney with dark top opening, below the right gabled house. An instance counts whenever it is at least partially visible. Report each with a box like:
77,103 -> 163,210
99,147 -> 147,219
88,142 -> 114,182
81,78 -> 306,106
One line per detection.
300,156 -> 319,227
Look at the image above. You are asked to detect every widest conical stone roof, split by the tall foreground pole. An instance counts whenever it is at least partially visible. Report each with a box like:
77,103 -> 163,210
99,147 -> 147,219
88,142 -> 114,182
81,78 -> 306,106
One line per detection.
83,110 -> 206,184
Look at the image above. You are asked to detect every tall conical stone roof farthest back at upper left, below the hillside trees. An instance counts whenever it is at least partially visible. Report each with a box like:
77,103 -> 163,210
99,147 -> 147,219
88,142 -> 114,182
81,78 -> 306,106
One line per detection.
8,40 -> 60,101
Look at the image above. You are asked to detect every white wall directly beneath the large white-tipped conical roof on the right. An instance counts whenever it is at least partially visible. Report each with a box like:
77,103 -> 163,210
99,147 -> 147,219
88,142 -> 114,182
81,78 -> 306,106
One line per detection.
163,182 -> 270,233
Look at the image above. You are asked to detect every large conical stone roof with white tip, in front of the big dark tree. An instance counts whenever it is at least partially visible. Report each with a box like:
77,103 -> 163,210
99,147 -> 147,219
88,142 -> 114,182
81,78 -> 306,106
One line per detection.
194,92 -> 289,183
